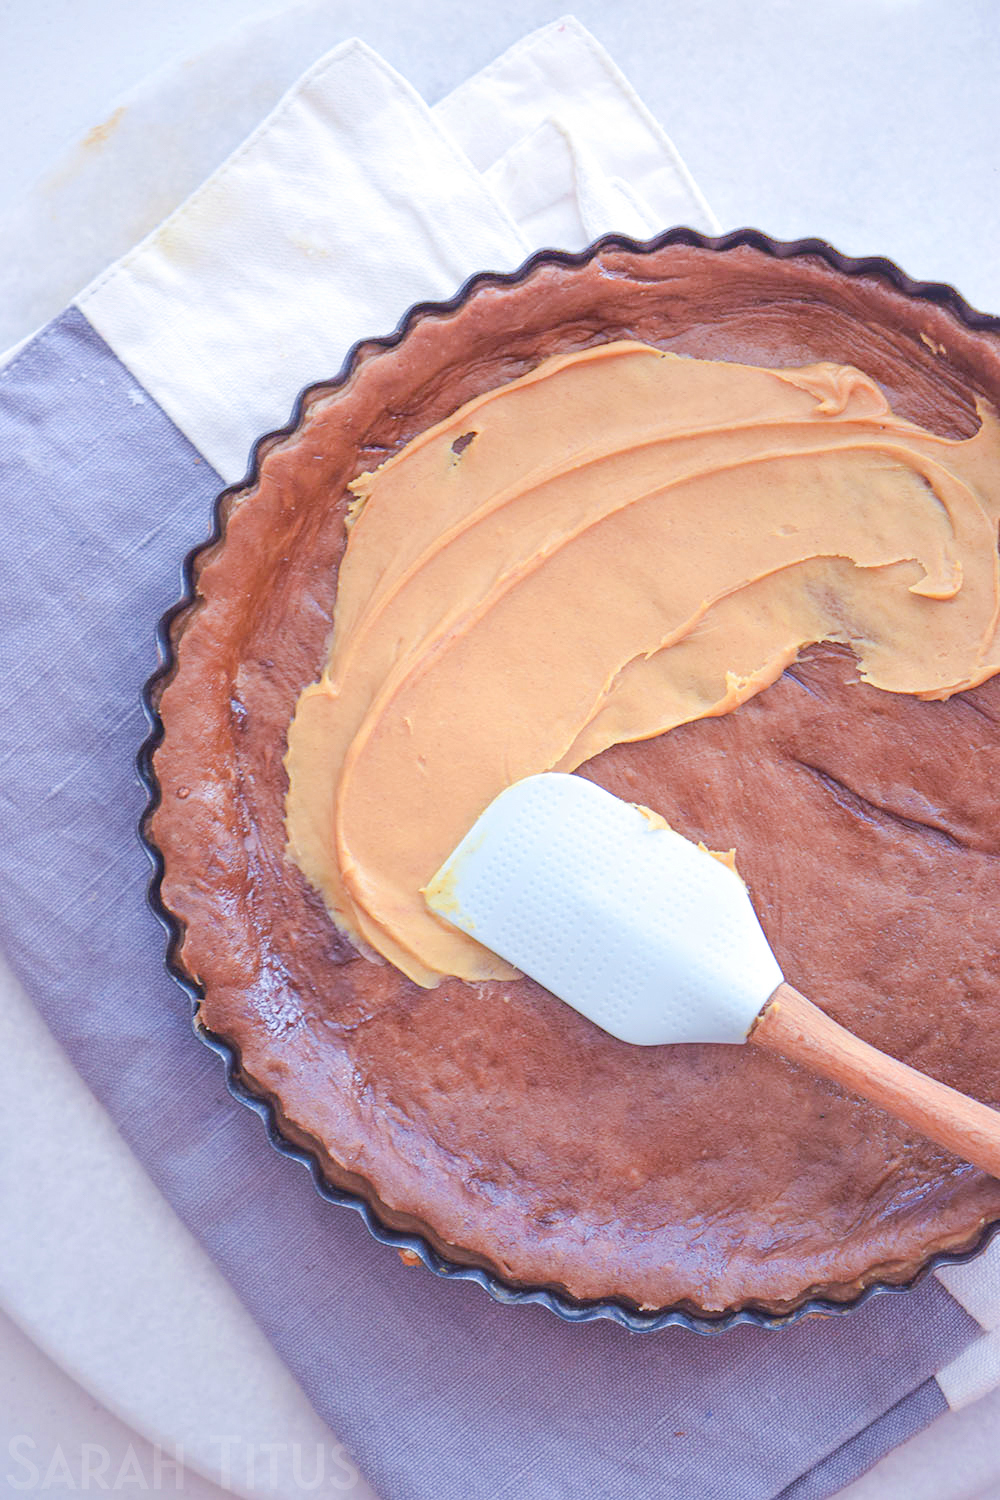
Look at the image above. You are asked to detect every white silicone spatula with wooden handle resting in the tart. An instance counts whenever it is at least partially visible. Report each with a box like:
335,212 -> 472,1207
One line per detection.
426,773 -> 1000,1178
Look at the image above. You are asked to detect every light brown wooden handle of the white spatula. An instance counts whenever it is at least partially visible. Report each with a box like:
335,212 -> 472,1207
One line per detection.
747,984 -> 1000,1178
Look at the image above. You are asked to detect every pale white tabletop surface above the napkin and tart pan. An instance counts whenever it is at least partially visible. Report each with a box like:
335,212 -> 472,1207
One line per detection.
7,0 -> 1000,316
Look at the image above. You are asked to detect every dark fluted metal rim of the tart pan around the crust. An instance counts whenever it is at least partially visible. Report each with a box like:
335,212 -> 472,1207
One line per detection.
136,228 -> 1000,1334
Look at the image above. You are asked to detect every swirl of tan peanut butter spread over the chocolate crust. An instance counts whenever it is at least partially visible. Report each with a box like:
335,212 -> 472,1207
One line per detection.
285,342 -> 1000,986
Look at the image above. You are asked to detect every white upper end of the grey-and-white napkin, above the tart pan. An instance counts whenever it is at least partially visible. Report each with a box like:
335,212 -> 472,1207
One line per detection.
76,20 -> 714,482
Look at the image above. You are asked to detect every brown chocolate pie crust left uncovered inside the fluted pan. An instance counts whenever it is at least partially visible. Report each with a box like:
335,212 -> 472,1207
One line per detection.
144,231 -> 1000,1319
